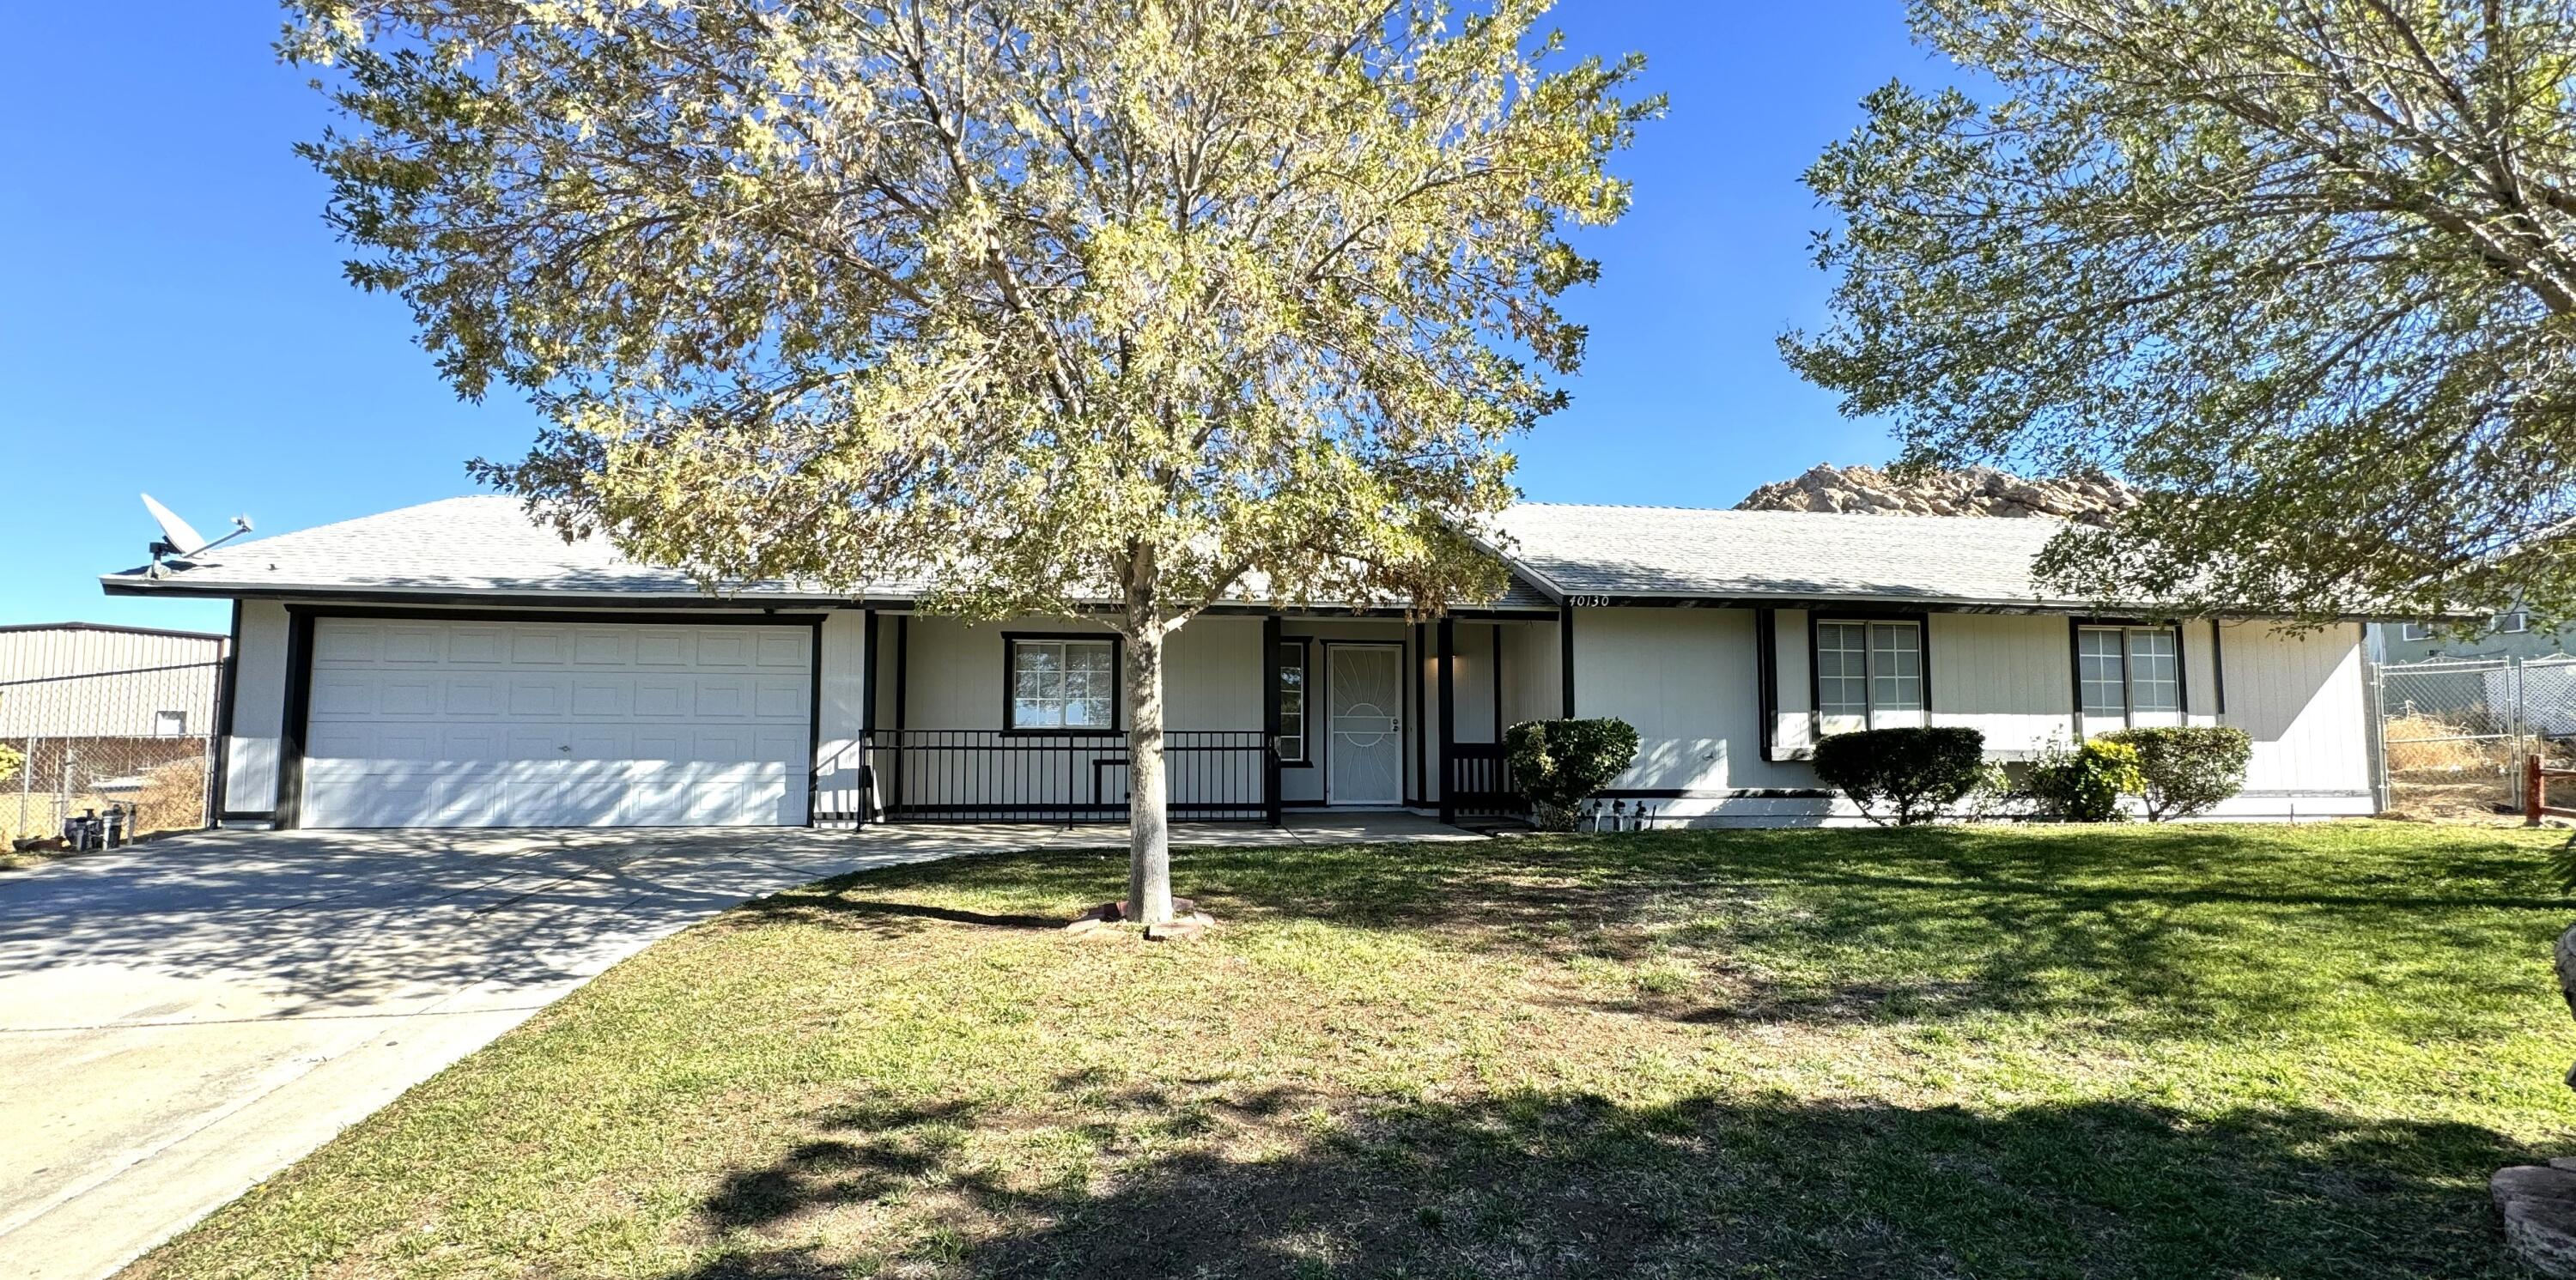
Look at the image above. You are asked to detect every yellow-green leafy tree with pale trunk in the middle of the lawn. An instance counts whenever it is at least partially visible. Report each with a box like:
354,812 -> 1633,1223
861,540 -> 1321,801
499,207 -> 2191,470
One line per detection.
283,0 -> 1656,922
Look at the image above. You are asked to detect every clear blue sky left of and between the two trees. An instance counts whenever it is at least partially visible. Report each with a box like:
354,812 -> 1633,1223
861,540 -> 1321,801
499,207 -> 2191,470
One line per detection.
0,0 -> 1942,628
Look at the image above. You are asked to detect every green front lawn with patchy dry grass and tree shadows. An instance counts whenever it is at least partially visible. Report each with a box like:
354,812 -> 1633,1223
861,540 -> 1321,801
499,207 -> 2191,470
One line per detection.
137,824 -> 2576,1280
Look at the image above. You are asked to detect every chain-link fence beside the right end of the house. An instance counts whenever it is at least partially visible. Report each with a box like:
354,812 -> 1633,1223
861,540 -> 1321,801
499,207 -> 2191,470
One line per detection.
2372,657 -> 2576,819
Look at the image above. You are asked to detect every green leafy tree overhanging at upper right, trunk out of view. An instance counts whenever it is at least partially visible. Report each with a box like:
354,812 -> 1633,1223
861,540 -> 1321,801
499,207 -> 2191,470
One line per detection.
1783,0 -> 2576,616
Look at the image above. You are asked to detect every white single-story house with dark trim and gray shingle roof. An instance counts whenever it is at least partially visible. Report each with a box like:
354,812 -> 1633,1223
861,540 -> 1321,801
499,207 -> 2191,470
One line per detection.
103,497 -> 2372,827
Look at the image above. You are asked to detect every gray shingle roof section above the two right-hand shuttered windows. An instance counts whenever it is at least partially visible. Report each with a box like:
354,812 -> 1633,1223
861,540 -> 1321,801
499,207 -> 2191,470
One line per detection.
1499,502 -> 2079,608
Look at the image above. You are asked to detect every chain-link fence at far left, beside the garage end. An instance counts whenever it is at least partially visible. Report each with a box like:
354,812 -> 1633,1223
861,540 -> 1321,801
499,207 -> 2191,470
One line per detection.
0,662 -> 224,840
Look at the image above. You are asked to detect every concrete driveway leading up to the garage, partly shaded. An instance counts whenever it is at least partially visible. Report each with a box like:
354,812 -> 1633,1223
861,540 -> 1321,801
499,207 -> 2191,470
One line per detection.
0,829 -> 969,1280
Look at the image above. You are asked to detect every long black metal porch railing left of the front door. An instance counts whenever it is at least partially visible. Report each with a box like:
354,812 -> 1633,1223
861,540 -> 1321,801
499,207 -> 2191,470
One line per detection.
868,729 -> 1278,822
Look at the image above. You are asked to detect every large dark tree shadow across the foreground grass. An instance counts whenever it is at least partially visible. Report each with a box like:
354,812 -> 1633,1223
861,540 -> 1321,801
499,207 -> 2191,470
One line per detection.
677,1095 -> 2532,1280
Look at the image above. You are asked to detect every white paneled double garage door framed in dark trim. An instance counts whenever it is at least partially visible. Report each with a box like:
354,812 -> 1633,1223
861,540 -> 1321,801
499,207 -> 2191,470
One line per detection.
301,618 -> 814,827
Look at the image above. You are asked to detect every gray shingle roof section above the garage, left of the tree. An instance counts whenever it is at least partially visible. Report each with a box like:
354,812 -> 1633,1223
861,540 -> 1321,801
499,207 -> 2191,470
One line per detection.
100,494 -> 1553,608
